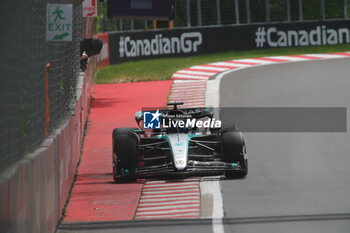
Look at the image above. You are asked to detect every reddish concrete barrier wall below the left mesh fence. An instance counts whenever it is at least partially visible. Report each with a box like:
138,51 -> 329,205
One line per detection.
0,67 -> 94,233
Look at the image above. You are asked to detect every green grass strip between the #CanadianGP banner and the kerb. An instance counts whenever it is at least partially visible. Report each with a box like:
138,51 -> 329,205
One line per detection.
94,44 -> 350,84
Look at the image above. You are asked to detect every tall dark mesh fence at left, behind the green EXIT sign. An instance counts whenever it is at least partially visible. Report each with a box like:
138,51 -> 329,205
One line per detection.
0,0 -> 86,170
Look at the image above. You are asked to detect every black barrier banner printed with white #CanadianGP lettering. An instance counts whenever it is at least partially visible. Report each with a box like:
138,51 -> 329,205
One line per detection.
109,20 -> 350,64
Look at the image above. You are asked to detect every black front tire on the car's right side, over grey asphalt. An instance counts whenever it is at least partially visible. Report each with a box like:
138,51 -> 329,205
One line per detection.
221,129 -> 248,178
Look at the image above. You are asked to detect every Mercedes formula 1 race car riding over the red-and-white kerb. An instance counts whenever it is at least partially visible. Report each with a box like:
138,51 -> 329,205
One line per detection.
112,103 -> 248,182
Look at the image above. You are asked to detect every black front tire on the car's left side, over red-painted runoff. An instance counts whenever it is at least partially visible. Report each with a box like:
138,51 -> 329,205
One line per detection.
113,128 -> 139,182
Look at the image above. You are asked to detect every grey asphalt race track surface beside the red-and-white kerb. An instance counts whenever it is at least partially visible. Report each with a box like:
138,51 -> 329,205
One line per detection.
58,59 -> 350,233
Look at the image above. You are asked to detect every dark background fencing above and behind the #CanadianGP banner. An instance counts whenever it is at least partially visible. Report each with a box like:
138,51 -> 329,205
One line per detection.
99,0 -> 350,31
